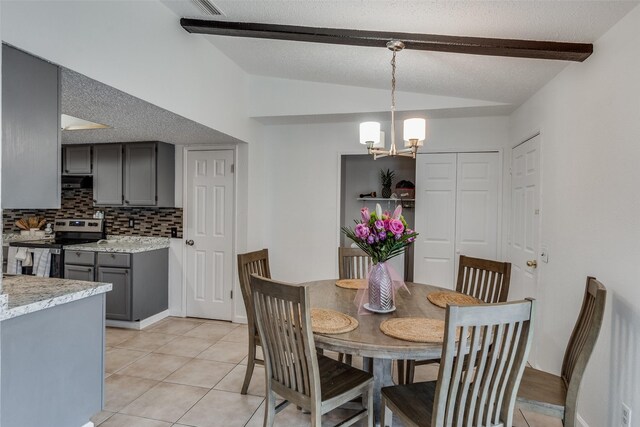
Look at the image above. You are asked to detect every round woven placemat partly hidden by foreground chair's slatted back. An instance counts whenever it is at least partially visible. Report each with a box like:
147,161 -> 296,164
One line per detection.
380,317 -> 444,343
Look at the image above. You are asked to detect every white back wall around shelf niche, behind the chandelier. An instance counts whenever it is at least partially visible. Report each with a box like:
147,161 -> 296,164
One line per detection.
256,117 -> 508,282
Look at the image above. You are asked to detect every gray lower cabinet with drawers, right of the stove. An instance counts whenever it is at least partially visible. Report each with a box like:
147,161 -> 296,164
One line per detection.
65,248 -> 169,321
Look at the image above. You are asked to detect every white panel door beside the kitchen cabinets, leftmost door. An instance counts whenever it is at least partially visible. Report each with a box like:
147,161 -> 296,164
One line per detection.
184,150 -> 234,320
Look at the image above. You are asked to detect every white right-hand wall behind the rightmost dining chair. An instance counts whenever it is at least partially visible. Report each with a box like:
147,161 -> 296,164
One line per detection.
509,7 -> 640,427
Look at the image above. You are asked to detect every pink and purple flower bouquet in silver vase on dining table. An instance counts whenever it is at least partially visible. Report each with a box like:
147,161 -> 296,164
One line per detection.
342,204 -> 418,313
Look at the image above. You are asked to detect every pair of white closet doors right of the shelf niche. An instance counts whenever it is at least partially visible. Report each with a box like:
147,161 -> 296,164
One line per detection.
414,153 -> 501,289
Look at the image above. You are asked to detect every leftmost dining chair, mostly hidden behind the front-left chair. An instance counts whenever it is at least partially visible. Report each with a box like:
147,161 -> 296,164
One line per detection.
238,249 -> 271,394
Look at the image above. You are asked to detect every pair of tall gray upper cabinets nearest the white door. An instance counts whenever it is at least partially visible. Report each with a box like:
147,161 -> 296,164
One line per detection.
93,142 -> 175,207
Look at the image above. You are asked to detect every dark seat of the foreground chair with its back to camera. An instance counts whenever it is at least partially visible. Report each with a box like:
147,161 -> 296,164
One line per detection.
382,381 -> 436,427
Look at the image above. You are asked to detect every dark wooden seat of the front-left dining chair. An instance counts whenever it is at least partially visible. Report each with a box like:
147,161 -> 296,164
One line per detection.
318,354 -> 373,402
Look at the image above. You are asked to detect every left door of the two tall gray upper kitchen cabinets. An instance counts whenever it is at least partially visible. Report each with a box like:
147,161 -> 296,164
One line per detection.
93,144 -> 123,206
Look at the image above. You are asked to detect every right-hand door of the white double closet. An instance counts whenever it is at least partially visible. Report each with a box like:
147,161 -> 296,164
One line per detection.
455,153 -> 500,274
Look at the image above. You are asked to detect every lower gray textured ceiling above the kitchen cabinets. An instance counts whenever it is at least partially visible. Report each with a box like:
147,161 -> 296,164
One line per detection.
60,67 -> 238,145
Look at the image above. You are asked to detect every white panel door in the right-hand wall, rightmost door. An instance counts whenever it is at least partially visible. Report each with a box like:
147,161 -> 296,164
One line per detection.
508,136 -> 540,300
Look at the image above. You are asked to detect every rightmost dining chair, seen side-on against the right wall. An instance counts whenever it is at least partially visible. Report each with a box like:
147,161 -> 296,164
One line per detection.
518,277 -> 607,427
